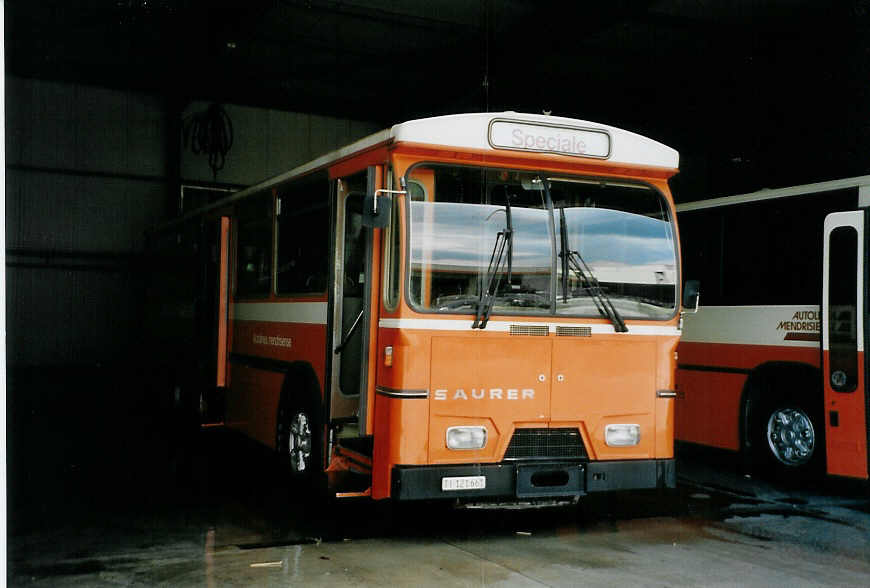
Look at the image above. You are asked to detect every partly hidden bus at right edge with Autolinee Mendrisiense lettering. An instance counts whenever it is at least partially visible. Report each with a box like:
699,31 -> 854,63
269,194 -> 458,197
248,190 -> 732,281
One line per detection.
676,176 -> 870,480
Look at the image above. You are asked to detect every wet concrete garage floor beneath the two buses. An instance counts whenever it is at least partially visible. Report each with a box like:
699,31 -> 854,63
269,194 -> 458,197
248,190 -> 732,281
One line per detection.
7,374 -> 870,588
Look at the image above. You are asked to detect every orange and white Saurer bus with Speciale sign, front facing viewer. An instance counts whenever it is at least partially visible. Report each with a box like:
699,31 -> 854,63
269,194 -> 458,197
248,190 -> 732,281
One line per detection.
154,112 -> 681,502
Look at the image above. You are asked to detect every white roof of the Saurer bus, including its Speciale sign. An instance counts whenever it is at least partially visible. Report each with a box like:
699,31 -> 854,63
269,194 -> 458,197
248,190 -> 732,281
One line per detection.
160,111 -> 680,228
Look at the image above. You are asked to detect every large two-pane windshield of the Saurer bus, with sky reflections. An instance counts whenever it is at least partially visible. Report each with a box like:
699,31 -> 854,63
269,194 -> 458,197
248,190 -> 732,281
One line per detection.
407,165 -> 677,322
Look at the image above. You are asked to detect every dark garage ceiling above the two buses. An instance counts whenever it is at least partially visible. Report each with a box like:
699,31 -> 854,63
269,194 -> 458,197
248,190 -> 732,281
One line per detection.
6,0 -> 870,198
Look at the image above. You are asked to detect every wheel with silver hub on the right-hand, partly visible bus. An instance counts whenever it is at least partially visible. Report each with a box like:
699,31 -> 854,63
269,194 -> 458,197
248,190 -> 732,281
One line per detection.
753,398 -> 825,481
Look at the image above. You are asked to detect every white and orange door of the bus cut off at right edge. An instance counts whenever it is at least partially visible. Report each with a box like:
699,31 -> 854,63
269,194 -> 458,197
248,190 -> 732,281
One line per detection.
822,211 -> 868,478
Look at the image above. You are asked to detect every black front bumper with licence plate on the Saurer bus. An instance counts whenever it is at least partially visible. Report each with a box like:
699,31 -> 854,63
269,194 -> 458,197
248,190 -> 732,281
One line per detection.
392,459 -> 677,500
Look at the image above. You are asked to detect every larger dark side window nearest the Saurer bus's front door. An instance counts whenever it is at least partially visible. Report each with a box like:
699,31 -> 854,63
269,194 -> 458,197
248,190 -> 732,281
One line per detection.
275,174 -> 329,295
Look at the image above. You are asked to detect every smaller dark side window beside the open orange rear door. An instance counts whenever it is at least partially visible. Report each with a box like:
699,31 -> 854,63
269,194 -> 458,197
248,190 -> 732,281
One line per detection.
236,194 -> 272,297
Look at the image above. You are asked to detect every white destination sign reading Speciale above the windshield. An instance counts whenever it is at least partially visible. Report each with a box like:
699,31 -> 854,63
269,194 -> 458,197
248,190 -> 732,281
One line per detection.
489,120 -> 610,158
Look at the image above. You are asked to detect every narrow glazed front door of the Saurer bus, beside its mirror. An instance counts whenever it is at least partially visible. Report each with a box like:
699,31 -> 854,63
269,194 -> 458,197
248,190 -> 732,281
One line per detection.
329,173 -> 372,435
